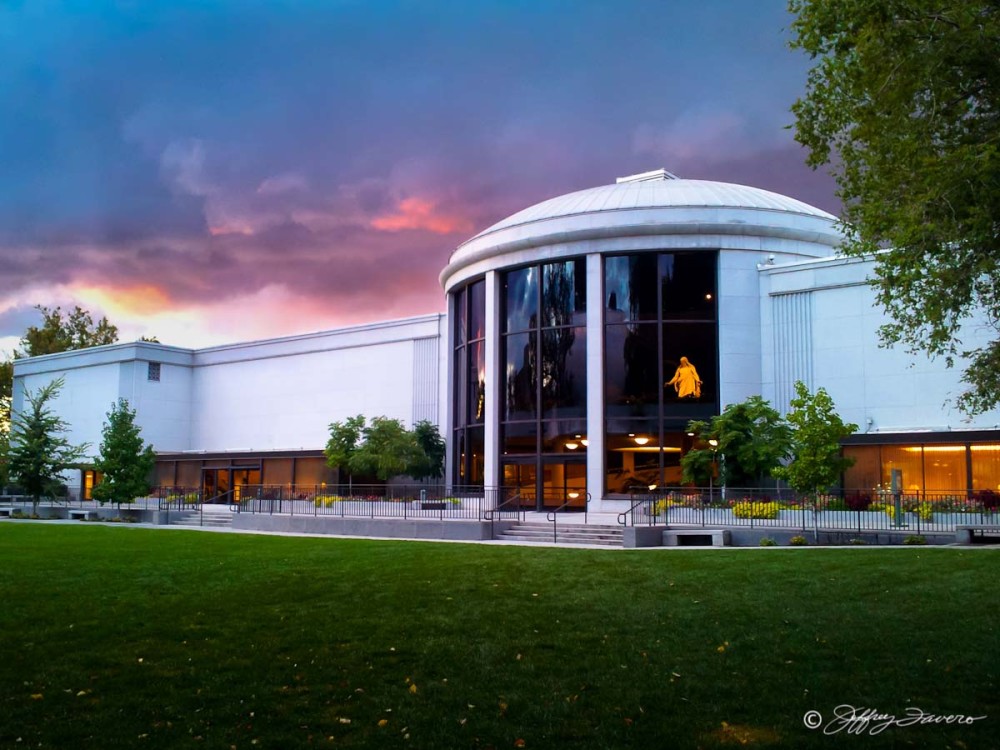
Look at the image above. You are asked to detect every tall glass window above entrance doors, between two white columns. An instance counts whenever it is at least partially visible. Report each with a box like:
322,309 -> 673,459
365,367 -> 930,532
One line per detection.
500,258 -> 587,507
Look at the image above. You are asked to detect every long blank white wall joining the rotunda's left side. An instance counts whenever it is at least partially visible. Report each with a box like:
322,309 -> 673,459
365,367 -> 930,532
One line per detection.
190,315 -> 442,451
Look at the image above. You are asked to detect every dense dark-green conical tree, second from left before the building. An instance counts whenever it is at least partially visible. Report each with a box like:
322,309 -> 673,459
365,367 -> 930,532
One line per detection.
93,398 -> 156,505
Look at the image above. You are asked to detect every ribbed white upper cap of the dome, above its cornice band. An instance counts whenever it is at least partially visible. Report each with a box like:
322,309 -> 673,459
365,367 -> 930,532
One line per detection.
476,169 -> 837,245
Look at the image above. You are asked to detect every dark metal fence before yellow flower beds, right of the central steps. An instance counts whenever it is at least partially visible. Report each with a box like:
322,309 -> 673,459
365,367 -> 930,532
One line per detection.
618,487 -> 1000,534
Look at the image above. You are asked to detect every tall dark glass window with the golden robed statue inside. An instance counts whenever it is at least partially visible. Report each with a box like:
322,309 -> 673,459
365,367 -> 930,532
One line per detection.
604,251 -> 719,500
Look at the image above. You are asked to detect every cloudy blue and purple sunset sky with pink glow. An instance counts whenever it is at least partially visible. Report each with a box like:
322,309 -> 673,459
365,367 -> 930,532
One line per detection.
0,0 -> 839,355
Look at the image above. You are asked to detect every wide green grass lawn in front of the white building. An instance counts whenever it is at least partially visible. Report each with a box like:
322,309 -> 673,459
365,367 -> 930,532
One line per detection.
0,521 -> 1000,750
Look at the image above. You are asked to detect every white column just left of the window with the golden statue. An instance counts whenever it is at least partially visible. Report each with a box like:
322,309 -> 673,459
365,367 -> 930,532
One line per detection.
587,253 -> 605,510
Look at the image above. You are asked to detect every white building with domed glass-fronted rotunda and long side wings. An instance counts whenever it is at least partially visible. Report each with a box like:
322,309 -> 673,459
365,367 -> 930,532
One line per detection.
14,170 -> 1000,507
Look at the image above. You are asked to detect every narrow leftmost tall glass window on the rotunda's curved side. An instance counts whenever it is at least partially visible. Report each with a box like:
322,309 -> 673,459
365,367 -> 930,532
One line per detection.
452,280 -> 486,485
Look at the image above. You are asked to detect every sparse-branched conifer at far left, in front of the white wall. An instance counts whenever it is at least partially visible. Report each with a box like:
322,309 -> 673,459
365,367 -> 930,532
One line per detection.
7,378 -> 88,512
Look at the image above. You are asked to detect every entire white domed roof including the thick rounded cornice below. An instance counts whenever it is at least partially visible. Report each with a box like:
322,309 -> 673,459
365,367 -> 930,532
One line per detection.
440,169 -> 842,289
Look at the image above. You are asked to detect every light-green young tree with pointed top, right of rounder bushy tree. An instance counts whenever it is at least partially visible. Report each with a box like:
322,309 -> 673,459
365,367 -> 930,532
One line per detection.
774,381 -> 858,502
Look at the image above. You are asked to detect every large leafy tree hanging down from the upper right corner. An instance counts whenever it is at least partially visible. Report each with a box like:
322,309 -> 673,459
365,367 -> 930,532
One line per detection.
789,0 -> 1000,414
